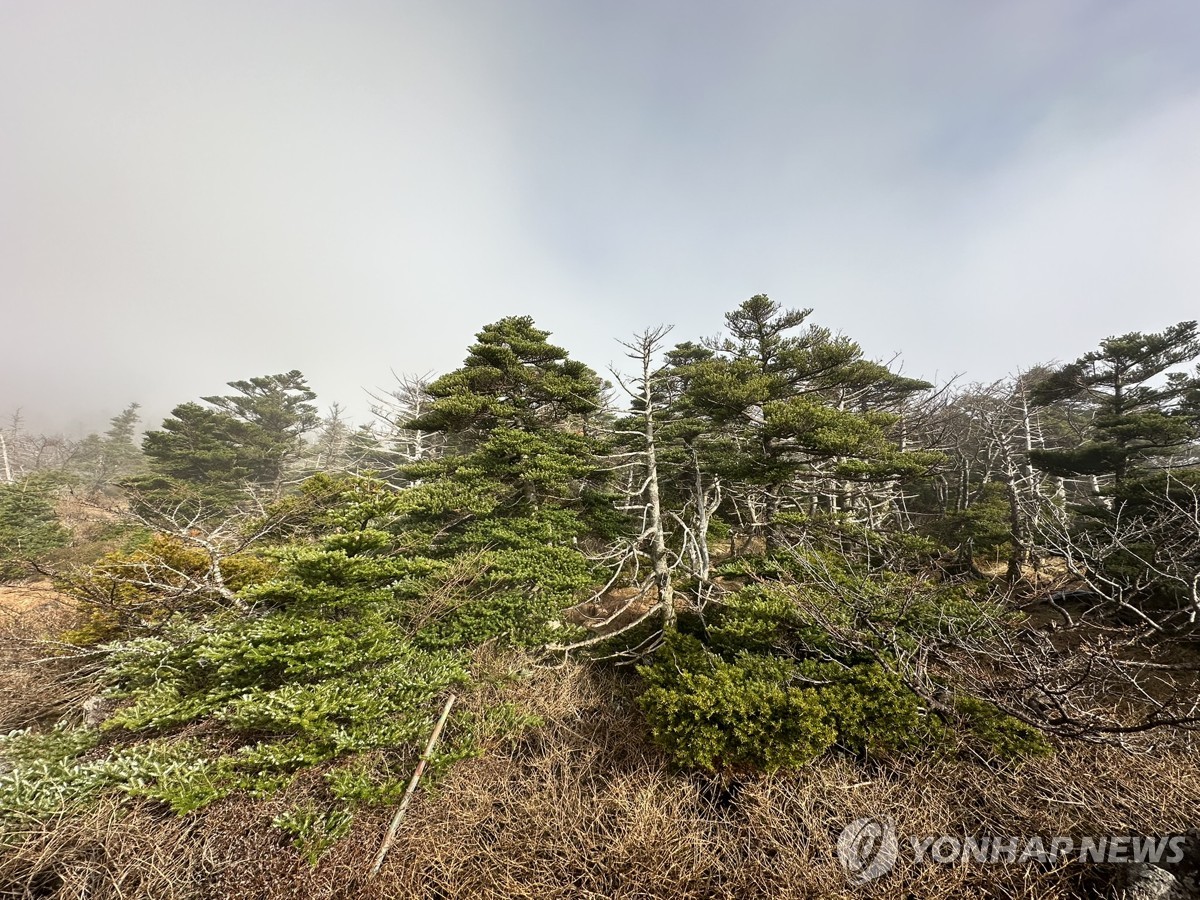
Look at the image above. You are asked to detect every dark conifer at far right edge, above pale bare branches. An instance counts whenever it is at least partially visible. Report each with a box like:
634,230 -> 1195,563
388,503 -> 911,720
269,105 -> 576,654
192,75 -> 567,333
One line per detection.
1030,322 -> 1200,632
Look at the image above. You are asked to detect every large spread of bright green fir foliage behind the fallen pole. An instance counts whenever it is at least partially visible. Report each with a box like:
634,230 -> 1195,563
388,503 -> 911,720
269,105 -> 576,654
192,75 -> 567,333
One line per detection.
0,465 -> 590,830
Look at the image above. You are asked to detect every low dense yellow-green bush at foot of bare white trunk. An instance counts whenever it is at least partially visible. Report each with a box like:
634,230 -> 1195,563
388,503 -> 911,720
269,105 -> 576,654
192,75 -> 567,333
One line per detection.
638,553 -> 1036,770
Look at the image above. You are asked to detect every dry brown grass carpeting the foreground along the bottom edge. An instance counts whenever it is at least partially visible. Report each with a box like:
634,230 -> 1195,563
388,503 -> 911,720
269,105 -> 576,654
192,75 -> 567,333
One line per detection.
0,660 -> 1200,900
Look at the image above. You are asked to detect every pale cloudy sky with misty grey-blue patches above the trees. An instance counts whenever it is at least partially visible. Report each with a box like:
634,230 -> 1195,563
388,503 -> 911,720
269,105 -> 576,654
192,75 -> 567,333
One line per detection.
0,0 -> 1200,433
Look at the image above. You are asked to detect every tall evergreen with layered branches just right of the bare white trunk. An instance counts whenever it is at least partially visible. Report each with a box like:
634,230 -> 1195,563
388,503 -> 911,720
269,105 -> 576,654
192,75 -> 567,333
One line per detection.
686,294 -> 934,550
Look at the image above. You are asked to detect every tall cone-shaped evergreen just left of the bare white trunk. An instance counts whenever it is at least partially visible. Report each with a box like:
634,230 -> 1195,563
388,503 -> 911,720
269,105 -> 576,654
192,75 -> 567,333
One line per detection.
401,317 -> 612,640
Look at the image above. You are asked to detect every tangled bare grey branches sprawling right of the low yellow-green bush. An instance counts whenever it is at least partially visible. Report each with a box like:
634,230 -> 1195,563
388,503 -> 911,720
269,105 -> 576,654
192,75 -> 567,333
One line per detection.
768,540 -> 1200,752
